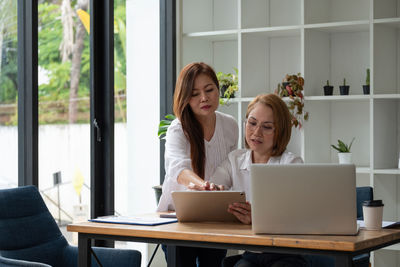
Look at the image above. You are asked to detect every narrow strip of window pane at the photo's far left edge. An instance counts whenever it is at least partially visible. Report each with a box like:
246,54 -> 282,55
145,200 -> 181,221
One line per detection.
0,0 -> 18,191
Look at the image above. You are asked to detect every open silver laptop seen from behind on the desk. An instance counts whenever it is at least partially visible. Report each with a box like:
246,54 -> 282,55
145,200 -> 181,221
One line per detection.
251,164 -> 358,235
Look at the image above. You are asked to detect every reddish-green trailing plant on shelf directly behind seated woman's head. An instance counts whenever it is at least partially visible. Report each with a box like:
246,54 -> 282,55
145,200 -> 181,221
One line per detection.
275,73 -> 309,128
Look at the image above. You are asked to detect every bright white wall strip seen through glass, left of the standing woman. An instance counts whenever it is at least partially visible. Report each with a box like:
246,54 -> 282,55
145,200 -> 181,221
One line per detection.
126,0 -> 161,266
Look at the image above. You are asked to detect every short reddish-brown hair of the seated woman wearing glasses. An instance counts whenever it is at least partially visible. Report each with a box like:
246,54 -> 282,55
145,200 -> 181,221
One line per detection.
245,94 -> 292,157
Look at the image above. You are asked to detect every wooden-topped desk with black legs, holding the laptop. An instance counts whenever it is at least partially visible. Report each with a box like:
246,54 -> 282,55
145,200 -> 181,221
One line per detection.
67,219 -> 400,267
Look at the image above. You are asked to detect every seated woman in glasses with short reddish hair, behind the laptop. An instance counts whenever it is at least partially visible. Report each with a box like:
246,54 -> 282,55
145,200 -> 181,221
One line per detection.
210,94 -> 307,267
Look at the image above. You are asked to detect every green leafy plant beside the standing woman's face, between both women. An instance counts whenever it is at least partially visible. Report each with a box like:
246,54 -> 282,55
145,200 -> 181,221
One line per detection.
217,68 -> 238,105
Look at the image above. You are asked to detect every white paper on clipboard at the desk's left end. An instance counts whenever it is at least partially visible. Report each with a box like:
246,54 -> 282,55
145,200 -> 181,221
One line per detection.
89,216 -> 178,225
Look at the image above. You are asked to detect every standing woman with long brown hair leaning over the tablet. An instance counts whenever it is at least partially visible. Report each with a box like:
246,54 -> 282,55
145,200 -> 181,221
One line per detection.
158,62 -> 238,266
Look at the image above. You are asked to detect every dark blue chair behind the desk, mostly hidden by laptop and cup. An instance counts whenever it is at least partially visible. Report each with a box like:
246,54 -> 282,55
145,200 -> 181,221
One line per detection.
222,186 -> 374,267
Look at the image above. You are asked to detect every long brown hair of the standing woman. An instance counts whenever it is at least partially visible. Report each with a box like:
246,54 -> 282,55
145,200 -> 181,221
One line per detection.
174,62 -> 219,179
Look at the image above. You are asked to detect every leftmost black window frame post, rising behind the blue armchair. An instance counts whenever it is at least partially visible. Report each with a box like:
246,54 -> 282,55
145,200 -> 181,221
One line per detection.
17,0 -> 39,187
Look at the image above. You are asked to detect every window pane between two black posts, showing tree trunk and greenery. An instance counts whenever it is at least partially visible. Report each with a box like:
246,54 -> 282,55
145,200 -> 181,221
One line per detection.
38,0 -> 90,242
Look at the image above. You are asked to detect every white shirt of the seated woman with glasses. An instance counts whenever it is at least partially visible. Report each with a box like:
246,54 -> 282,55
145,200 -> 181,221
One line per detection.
210,149 -> 303,201
